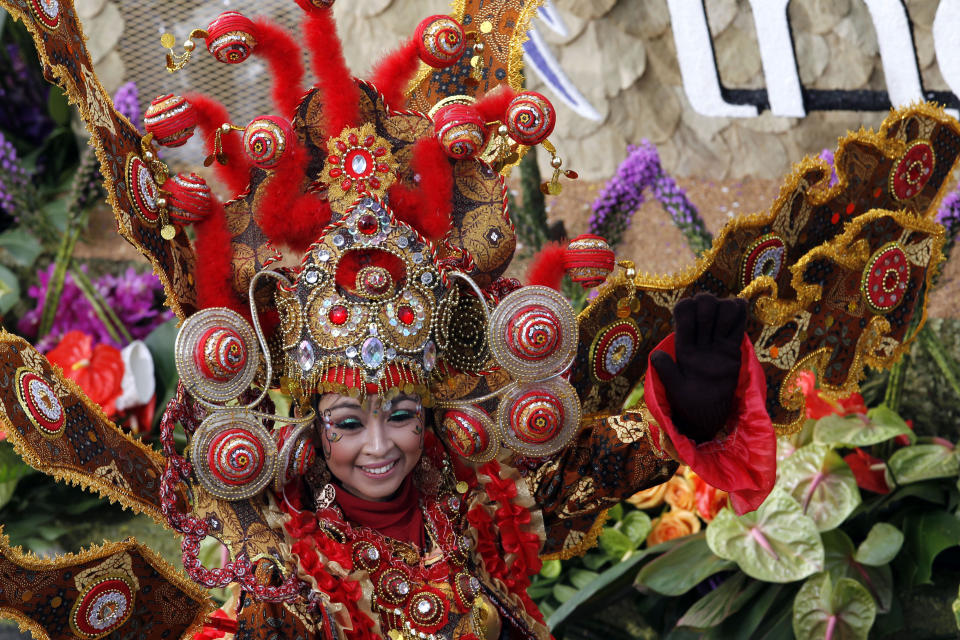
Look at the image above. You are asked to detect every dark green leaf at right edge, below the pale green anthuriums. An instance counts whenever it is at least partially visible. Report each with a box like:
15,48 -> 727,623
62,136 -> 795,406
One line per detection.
895,510 -> 960,587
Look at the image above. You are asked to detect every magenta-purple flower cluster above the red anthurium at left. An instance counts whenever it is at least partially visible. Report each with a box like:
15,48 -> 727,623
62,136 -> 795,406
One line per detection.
17,264 -> 173,351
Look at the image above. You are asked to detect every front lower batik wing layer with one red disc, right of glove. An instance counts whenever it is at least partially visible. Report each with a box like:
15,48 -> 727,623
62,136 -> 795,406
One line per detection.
747,209 -> 944,433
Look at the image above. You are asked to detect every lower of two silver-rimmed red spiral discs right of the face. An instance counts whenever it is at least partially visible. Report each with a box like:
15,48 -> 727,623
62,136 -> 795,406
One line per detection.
497,378 -> 580,457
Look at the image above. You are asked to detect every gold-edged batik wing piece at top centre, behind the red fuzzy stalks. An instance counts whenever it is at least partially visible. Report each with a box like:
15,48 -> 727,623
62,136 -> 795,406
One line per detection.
407,0 -> 542,113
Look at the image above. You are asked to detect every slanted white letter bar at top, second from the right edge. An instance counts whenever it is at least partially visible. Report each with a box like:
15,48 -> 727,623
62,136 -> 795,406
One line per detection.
864,0 -> 928,107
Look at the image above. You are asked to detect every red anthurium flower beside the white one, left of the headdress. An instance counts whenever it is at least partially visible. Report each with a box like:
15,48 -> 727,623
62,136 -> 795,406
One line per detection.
47,331 -> 123,416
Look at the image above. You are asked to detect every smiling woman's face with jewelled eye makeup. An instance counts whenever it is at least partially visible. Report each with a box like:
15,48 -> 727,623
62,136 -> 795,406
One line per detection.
317,393 -> 423,500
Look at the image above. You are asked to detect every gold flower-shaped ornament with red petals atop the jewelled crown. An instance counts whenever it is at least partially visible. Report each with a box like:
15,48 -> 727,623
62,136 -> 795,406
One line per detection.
321,122 -> 397,212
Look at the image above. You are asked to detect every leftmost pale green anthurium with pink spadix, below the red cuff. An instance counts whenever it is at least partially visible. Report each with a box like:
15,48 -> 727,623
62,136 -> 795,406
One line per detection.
707,487 -> 824,582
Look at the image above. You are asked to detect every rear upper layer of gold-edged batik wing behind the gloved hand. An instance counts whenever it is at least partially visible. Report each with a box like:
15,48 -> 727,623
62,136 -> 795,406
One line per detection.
571,104 -> 960,428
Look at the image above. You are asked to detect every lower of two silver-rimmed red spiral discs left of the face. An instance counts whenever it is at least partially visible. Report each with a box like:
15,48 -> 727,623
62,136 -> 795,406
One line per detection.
190,410 -> 278,500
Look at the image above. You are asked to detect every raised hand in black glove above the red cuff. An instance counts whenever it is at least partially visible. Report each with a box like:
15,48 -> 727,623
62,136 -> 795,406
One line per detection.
650,293 -> 747,443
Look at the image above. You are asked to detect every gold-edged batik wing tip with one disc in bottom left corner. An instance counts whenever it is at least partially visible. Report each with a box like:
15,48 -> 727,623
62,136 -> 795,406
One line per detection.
0,536 -> 212,640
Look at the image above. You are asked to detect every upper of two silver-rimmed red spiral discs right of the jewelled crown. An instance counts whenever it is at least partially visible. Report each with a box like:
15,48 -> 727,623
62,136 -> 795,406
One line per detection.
489,286 -> 577,380
